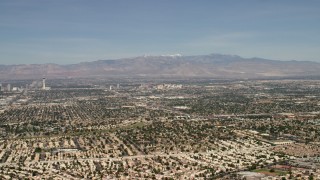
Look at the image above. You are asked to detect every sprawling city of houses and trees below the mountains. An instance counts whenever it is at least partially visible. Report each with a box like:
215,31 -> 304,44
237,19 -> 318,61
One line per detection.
0,78 -> 320,180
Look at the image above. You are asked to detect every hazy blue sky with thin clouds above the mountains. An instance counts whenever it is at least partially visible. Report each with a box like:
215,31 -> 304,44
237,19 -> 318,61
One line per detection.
0,0 -> 320,64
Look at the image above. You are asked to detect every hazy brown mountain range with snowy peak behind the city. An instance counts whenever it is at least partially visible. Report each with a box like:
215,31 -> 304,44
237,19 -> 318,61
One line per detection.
0,54 -> 320,79
